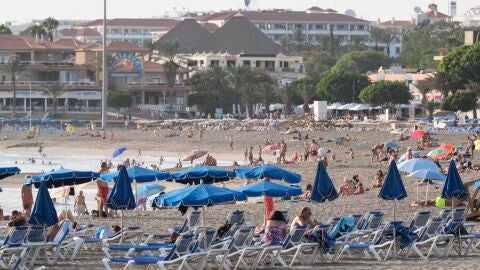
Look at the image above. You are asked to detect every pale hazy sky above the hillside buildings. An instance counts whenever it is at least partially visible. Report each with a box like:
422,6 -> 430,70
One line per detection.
0,0 -> 480,23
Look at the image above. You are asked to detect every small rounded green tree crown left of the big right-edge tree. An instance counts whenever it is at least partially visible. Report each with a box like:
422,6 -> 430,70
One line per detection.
359,81 -> 412,107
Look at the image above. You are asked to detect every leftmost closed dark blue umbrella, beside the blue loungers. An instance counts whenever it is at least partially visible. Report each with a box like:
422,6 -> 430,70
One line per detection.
28,182 -> 58,227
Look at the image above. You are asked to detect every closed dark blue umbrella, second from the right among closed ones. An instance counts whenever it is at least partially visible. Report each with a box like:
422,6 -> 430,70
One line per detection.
378,160 -> 407,200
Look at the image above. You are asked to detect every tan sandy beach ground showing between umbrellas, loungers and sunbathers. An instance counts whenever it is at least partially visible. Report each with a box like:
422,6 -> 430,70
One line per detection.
0,127 -> 480,269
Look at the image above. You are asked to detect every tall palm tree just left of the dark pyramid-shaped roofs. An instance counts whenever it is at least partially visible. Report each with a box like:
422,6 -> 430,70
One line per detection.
156,39 -> 180,111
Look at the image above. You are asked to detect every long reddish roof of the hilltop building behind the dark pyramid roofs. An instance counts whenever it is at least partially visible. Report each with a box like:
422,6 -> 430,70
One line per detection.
197,9 -> 368,23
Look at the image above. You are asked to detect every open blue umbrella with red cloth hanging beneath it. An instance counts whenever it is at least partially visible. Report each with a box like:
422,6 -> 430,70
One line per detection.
236,181 -> 302,197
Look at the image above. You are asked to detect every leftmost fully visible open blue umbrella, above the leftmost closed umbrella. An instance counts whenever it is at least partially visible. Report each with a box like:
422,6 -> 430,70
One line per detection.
24,168 -> 100,188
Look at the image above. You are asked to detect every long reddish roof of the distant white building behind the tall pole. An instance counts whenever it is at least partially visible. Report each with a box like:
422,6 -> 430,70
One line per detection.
77,18 -> 178,28
